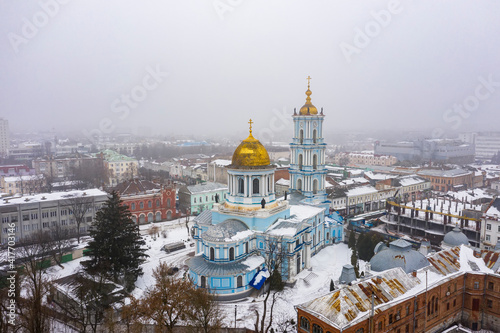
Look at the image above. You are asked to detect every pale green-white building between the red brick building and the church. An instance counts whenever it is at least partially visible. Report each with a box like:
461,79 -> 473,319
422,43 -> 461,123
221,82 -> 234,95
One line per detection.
179,182 -> 228,215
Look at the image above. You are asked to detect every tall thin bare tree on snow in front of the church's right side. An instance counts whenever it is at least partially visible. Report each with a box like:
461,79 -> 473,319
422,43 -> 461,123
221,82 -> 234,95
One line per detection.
254,237 -> 287,333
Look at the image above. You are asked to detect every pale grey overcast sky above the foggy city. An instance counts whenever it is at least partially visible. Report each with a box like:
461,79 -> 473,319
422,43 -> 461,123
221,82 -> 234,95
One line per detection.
0,0 -> 500,140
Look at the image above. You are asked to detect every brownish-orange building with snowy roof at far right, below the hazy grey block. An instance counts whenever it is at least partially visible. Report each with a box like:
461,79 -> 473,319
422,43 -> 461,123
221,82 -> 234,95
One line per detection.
417,169 -> 474,192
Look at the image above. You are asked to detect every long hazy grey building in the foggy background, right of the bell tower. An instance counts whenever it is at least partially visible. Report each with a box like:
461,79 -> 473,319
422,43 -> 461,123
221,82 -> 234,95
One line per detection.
374,139 -> 474,163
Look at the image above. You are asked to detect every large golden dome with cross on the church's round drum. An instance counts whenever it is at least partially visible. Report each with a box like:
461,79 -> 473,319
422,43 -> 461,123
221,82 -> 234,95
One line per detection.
231,119 -> 271,167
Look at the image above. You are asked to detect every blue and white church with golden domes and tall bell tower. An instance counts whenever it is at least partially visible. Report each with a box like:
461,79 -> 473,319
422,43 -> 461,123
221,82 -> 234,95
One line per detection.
188,77 -> 343,299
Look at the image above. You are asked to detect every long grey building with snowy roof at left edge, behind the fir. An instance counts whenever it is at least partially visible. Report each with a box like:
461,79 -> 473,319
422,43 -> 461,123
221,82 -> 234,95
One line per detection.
0,189 -> 108,244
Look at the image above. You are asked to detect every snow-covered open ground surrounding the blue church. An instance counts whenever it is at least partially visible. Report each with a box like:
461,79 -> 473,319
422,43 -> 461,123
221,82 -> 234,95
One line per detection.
48,219 -> 365,328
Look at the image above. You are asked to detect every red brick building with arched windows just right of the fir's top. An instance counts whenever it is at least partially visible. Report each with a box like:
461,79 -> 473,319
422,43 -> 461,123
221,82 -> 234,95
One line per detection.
114,179 -> 179,224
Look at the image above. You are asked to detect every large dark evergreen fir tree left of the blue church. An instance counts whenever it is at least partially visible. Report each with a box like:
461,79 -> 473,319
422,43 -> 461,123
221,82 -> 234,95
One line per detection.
82,191 -> 147,290
